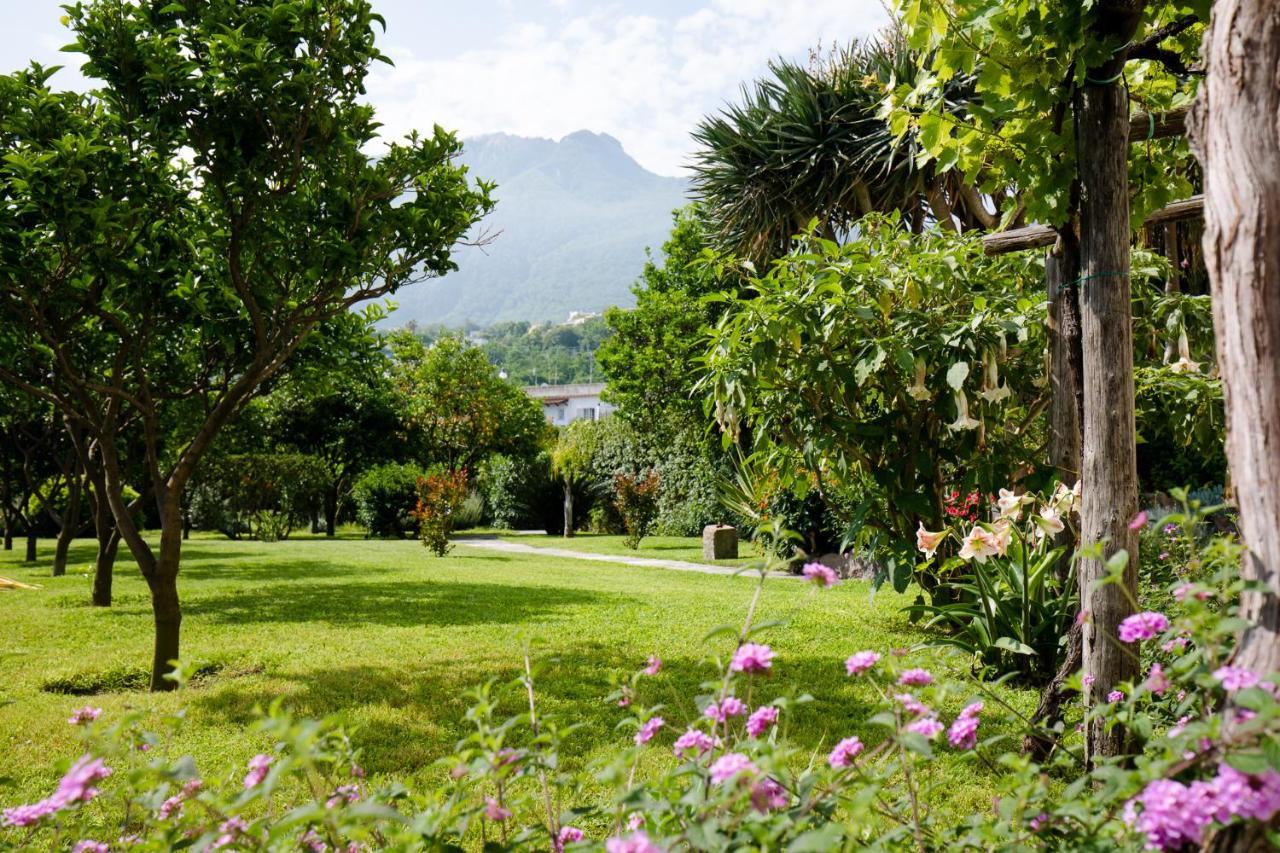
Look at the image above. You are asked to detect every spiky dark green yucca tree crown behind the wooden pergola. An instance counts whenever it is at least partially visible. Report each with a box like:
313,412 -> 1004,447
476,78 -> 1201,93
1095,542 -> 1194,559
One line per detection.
692,31 -> 996,263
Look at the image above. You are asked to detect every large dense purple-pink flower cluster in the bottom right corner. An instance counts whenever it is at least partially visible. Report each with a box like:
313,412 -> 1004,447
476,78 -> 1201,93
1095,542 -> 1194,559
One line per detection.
1125,765 -> 1280,850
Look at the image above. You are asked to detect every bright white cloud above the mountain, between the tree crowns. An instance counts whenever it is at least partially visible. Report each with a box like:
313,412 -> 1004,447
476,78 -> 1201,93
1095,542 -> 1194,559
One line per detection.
369,0 -> 886,174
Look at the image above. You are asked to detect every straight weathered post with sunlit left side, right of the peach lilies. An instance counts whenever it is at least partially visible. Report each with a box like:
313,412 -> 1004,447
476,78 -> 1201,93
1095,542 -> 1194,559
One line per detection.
1075,18 -> 1142,762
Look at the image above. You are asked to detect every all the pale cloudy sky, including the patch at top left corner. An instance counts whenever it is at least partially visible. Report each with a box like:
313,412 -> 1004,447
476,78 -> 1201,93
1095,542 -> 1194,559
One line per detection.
0,0 -> 886,174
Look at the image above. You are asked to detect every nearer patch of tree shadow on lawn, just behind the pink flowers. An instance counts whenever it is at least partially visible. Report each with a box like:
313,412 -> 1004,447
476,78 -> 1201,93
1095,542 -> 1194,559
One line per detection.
189,643 -> 911,776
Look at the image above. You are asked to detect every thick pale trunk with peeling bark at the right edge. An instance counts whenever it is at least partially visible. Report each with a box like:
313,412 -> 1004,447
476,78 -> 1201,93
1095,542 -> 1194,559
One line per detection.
1189,0 -> 1280,676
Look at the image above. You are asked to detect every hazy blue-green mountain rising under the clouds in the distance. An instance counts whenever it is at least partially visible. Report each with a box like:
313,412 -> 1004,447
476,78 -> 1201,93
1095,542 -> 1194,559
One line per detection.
388,131 -> 687,325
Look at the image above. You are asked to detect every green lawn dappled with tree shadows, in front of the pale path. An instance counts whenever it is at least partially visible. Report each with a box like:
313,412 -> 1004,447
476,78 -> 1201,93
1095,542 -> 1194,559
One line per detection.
0,537 -> 1034,813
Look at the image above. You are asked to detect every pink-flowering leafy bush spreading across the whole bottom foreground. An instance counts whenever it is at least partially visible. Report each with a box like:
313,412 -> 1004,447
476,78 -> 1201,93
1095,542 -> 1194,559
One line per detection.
10,520 -> 1280,853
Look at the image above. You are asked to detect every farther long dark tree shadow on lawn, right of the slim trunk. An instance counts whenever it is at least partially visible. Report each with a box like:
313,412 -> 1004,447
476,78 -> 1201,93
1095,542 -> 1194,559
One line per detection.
183,569 -> 631,626
